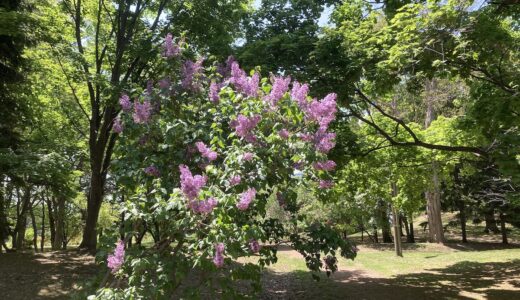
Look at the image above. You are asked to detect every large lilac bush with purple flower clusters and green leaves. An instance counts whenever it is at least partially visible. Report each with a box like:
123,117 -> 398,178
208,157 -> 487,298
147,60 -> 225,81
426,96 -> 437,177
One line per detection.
91,36 -> 355,298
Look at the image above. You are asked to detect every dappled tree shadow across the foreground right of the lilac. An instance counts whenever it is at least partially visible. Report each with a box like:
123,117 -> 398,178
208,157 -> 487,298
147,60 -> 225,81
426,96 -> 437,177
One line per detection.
262,260 -> 520,300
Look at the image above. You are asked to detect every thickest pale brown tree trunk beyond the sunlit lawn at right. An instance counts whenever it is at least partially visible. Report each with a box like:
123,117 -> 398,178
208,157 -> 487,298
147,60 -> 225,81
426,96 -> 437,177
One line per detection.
426,161 -> 444,243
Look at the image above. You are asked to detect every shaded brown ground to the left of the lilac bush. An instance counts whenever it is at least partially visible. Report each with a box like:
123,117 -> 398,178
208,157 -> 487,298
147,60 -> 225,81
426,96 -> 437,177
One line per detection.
0,251 -> 96,300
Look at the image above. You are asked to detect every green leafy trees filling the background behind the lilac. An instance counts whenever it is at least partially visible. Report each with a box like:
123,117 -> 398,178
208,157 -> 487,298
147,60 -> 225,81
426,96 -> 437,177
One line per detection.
0,0 -> 520,292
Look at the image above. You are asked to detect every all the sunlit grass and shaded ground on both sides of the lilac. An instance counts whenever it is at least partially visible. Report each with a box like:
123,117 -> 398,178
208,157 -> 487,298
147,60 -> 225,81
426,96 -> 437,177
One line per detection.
0,216 -> 520,300
